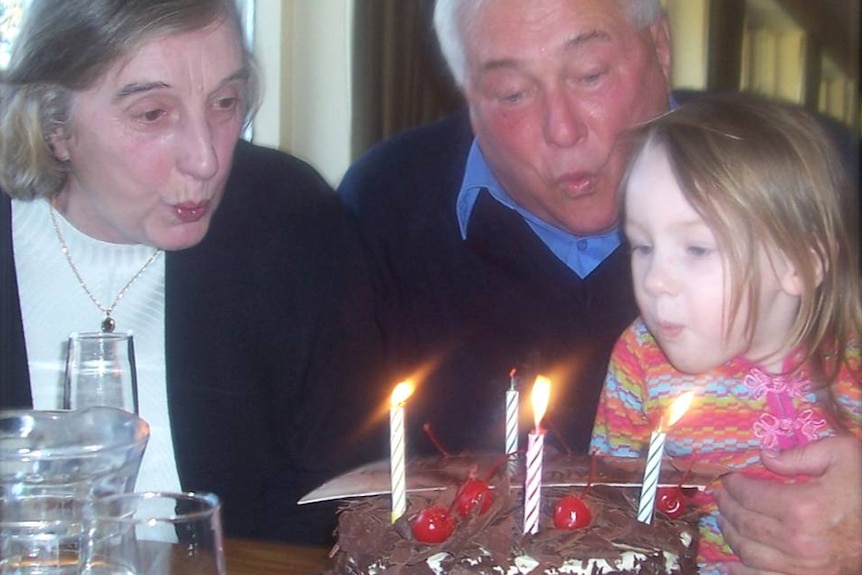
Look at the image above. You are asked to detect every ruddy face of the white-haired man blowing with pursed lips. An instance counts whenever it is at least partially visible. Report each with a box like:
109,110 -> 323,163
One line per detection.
464,0 -> 670,235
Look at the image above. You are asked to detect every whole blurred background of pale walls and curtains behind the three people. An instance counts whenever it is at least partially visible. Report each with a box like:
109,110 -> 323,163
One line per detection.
0,0 -> 860,185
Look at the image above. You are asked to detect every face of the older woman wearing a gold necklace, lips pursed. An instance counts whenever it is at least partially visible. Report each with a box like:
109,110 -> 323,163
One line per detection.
53,22 -> 248,250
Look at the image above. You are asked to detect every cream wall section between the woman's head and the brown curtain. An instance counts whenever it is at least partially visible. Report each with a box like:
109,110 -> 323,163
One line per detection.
254,0 -> 353,186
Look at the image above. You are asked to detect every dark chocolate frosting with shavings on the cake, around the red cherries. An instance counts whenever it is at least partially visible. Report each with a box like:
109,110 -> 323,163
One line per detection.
334,462 -> 699,575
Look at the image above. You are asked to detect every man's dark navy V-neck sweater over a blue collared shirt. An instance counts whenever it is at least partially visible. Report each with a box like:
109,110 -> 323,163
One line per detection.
339,113 -> 636,460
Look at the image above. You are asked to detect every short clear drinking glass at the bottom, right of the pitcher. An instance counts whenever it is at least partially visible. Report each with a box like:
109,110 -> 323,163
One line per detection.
81,492 -> 227,575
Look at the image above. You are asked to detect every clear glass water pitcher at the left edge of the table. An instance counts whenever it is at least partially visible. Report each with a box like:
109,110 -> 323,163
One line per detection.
0,407 -> 150,575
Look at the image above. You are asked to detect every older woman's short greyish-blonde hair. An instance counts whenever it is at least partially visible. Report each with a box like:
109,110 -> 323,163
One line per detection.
0,0 -> 258,199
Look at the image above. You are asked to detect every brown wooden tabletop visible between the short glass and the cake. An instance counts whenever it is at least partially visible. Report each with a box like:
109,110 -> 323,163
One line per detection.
224,539 -> 332,575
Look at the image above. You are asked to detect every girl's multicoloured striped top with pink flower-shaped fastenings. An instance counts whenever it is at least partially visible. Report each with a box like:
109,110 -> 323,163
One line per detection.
591,319 -> 862,575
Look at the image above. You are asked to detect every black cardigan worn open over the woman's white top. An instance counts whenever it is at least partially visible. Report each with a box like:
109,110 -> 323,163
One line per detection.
0,142 -> 382,543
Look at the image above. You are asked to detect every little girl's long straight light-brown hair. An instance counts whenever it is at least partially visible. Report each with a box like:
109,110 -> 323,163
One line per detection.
632,94 -> 862,385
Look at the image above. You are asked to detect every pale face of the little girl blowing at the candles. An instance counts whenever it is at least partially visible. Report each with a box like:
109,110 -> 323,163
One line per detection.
624,143 -> 799,373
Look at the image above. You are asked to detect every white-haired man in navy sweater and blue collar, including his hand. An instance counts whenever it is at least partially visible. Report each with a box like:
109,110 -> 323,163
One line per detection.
340,0 -> 862,573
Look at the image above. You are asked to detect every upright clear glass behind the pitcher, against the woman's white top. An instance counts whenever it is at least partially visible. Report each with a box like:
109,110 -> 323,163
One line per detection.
63,332 -> 138,415
